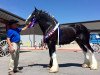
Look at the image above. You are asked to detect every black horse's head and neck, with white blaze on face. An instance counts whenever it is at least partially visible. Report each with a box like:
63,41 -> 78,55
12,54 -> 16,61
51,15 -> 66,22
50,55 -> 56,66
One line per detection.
26,8 -> 58,33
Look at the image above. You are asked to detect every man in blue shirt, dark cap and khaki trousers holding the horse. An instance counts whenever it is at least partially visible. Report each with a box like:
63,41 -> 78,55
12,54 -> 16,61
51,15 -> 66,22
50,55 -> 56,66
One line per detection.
7,20 -> 28,75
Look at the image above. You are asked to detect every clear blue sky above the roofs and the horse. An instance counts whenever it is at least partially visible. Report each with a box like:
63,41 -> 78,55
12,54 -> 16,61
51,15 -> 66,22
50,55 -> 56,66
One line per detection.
0,0 -> 100,23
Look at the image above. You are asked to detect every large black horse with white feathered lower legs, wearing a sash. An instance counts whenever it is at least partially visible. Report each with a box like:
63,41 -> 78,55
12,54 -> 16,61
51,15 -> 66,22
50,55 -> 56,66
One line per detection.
26,8 -> 97,72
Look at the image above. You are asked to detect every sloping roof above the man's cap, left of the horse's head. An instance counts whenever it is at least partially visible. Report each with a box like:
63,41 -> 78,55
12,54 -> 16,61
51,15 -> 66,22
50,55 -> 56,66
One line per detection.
0,8 -> 25,34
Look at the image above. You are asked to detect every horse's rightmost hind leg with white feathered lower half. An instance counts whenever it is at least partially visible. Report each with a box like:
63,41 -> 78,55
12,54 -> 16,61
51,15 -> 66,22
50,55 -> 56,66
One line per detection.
85,43 -> 98,70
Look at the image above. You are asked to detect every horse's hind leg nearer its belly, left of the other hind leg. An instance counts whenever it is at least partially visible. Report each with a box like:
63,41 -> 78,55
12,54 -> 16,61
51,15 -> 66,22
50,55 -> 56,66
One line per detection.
76,39 -> 90,68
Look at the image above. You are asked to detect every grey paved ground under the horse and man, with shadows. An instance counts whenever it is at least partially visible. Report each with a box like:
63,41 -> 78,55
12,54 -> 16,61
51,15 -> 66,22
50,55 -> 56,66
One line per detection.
0,50 -> 100,75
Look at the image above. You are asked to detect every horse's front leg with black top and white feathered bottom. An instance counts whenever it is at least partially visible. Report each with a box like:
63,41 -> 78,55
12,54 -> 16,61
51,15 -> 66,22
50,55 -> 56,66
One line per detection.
49,44 -> 59,73
